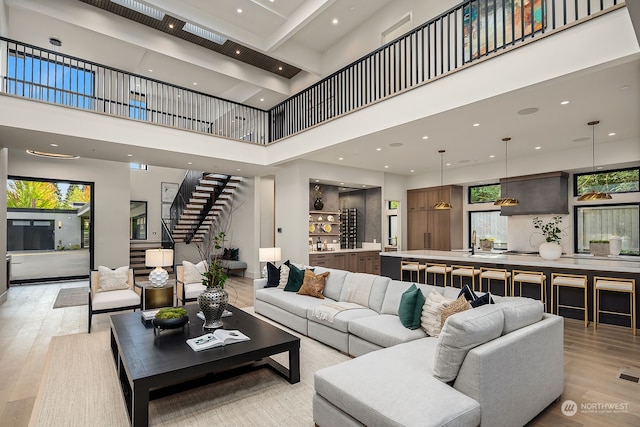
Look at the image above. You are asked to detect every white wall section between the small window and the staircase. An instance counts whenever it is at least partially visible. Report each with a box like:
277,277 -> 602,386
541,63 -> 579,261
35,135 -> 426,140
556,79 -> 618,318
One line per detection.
130,166 -> 186,242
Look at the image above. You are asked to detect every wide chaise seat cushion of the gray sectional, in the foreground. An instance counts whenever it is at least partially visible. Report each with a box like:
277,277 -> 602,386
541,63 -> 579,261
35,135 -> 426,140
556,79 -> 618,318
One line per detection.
314,338 -> 480,427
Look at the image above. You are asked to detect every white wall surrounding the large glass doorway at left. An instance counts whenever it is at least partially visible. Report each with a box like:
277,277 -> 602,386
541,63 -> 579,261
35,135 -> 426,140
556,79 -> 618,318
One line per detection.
8,150 -> 130,267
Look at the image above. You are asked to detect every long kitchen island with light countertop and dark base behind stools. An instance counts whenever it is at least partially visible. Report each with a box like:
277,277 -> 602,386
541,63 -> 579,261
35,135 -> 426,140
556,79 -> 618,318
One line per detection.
380,250 -> 640,327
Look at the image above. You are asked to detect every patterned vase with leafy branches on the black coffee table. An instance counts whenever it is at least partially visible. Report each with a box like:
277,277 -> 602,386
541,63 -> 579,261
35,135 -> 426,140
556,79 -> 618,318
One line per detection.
196,231 -> 229,329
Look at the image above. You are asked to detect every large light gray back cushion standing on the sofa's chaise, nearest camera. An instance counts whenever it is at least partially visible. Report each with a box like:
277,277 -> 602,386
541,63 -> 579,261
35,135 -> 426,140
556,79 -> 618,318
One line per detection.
433,304 -> 504,382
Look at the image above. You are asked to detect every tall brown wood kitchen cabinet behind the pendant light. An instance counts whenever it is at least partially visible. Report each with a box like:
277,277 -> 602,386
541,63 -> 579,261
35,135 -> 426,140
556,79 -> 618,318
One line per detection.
407,185 -> 462,251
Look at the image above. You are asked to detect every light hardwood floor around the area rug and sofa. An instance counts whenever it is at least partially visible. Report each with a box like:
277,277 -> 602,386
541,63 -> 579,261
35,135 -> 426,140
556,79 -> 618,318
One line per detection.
0,276 -> 640,427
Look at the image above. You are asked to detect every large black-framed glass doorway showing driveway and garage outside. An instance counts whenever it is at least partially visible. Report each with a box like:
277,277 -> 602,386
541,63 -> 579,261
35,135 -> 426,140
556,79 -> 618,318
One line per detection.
6,176 -> 94,285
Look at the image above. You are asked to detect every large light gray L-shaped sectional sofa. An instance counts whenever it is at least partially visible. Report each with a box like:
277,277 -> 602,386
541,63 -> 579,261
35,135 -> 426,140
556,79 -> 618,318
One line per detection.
254,267 -> 564,427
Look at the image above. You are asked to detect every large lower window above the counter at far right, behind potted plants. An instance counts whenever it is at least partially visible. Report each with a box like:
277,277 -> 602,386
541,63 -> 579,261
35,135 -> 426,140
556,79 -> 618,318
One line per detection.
575,203 -> 640,255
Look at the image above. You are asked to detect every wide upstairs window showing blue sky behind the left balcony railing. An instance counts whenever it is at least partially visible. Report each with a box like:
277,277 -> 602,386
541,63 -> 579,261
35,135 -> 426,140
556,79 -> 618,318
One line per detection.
7,51 -> 94,109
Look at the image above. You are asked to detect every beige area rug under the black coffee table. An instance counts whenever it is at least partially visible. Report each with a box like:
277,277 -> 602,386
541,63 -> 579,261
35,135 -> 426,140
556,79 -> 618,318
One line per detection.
29,312 -> 350,427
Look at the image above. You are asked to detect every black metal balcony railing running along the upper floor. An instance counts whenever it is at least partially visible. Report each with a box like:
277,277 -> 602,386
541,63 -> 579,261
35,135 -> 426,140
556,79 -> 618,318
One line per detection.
0,0 -> 624,144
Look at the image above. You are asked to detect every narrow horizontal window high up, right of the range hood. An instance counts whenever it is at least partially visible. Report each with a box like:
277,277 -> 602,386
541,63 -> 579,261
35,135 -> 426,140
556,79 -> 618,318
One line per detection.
573,168 -> 640,196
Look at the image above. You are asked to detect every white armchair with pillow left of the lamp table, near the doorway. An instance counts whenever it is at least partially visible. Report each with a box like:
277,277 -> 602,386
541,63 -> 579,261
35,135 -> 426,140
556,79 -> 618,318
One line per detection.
87,266 -> 142,333
